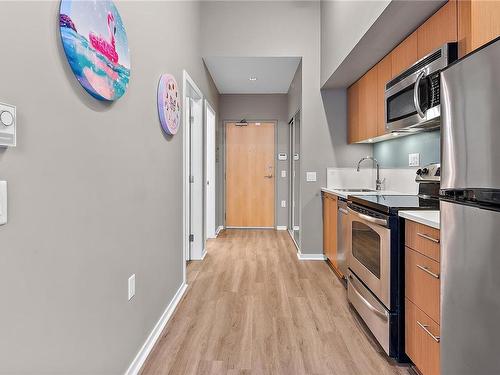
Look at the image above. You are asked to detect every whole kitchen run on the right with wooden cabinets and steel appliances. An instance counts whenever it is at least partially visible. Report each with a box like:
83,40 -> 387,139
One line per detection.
322,1 -> 500,375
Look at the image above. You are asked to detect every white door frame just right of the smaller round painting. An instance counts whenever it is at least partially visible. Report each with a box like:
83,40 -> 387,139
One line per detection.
182,70 -> 204,283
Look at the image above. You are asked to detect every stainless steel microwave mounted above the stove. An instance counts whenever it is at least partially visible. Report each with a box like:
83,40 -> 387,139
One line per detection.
385,43 -> 458,132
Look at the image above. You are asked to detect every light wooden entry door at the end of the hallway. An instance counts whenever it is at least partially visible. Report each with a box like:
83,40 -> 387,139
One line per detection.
226,122 -> 275,227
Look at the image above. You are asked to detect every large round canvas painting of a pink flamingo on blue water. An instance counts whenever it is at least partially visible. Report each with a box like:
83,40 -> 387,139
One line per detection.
59,0 -> 130,101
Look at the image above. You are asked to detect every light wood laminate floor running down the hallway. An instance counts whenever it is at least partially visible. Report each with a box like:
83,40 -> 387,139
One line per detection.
142,230 -> 409,375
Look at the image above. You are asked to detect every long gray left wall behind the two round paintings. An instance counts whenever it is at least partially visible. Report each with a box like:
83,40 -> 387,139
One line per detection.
0,1 -> 217,374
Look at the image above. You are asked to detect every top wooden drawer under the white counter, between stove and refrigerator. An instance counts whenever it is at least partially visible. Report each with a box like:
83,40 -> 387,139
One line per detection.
405,220 -> 439,262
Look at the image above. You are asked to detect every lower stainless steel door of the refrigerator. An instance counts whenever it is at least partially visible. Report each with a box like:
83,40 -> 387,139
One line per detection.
441,201 -> 500,375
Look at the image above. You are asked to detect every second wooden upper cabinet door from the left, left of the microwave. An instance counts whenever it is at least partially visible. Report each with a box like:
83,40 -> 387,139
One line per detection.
359,65 -> 378,141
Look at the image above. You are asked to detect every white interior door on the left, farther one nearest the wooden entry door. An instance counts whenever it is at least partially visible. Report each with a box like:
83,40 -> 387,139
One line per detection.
205,101 -> 216,238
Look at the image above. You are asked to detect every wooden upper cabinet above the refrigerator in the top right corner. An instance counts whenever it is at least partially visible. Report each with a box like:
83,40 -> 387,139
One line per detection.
458,0 -> 500,57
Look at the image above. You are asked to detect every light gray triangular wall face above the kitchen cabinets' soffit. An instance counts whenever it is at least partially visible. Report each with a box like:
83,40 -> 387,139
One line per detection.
321,0 -> 392,86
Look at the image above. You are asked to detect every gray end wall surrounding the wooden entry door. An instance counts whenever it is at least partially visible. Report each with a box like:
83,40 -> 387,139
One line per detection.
217,94 -> 289,226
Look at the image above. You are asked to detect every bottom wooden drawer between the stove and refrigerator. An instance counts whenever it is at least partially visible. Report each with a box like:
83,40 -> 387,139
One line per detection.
405,299 -> 440,375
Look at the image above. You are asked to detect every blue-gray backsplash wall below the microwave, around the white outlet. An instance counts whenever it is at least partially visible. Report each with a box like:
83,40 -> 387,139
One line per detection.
373,130 -> 441,168
